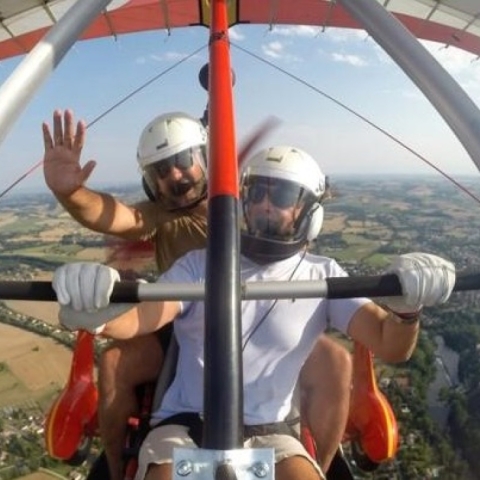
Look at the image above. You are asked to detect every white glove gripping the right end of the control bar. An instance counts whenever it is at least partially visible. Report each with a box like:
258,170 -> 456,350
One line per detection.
382,253 -> 455,313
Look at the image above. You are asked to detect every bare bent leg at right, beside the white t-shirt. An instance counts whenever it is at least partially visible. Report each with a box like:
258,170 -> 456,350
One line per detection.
300,335 -> 352,472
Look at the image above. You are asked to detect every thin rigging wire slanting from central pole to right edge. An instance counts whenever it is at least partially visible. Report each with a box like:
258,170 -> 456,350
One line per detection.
230,42 -> 480,204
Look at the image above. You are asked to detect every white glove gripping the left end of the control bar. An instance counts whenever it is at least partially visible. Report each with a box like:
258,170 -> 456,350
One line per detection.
52,263 -> 134,334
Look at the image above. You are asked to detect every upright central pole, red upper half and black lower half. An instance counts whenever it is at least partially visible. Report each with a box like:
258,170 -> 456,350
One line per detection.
203,0 -> 243,450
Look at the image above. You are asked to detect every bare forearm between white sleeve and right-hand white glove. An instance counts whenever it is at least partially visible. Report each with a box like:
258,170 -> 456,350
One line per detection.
347,302 -> 419,363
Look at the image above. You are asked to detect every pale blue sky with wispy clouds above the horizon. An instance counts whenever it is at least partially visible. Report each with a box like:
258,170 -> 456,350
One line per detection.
0,22 -> 480,193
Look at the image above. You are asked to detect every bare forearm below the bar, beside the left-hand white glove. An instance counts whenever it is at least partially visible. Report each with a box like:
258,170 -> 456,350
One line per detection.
102,302 -> 180,340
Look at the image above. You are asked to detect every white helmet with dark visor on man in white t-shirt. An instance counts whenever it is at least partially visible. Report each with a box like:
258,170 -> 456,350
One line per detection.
241,146 -> 326,261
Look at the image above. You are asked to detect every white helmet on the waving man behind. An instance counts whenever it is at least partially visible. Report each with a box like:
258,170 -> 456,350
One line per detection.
137,112 -> 207,200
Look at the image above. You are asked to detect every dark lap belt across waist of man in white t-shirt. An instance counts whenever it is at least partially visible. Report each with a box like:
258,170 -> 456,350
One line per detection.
153,412 -> 300,447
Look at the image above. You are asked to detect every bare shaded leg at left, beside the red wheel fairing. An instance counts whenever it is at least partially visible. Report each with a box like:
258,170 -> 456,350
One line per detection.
98,334 -> 163,480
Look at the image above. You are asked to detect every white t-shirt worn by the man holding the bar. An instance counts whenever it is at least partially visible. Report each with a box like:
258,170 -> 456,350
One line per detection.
153,250 -> 370,425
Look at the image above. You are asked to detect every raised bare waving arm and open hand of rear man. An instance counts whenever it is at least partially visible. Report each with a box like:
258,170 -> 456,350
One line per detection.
42,110 -> 153,239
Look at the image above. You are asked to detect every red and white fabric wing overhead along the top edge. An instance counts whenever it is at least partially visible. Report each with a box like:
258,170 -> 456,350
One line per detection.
0,0 -> 480,60
